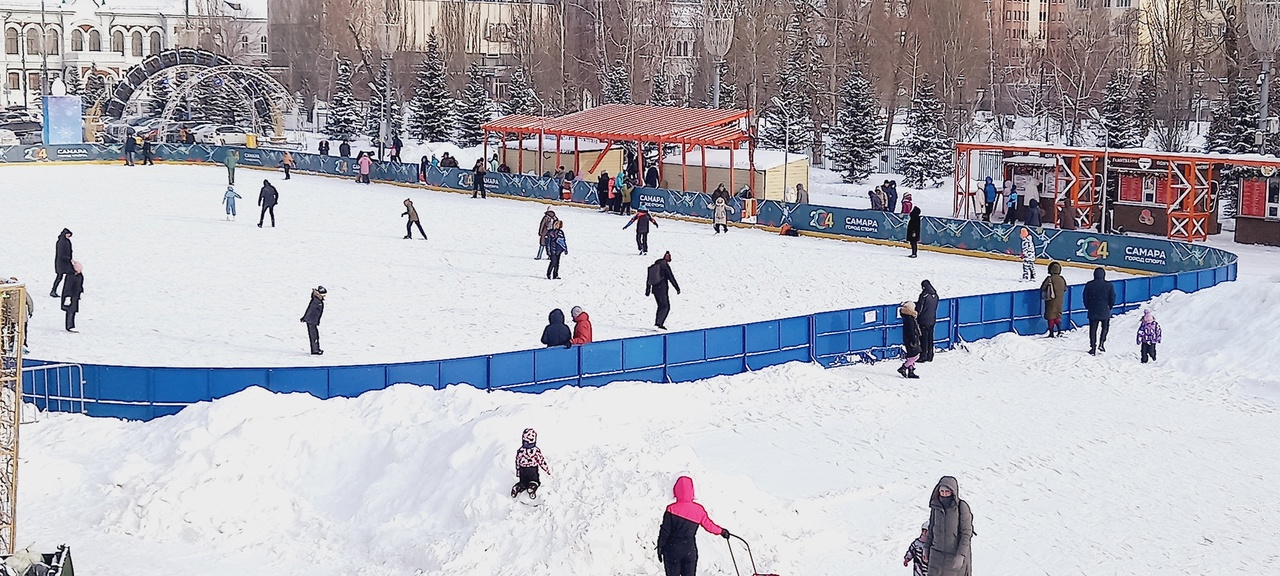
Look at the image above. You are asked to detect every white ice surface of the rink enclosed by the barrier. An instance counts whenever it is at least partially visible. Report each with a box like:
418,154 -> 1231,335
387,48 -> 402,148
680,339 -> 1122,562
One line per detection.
0,165 -> 1089,366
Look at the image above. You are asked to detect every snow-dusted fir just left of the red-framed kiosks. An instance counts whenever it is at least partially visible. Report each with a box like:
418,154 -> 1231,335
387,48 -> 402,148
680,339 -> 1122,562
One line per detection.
897,77 -> 955,188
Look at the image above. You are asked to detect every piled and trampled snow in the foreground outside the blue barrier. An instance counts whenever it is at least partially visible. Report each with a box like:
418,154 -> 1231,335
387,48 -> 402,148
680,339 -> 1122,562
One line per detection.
18,244 -> 1280,576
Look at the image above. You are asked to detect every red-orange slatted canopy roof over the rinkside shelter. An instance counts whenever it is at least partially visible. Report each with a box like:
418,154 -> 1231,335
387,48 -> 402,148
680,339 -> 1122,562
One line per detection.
481,104 -> 750,146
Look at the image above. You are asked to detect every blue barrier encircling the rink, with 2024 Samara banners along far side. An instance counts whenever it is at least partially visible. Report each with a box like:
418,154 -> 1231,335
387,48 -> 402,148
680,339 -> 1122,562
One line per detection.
0,139 -> 1238,420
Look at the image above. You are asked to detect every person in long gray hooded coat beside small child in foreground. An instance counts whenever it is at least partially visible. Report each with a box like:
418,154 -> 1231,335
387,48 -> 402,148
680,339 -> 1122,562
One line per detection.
924,476 -> 973,576
